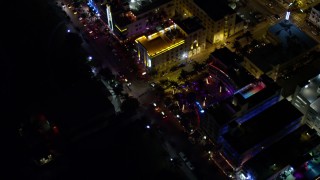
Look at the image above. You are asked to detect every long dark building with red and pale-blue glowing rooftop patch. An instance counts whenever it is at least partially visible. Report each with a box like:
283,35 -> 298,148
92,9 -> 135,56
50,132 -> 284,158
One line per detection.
200,73 -> 281,142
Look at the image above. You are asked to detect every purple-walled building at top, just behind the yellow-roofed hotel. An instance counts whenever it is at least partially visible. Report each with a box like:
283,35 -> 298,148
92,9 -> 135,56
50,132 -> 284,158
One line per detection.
108,0 -> 175,39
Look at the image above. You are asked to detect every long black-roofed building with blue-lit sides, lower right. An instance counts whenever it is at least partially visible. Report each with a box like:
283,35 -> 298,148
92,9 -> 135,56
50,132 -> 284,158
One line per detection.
220,99 -> 303,169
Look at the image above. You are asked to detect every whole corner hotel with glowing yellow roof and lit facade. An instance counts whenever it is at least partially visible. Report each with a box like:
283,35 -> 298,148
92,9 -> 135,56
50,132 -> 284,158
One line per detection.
136,18 -> 206,69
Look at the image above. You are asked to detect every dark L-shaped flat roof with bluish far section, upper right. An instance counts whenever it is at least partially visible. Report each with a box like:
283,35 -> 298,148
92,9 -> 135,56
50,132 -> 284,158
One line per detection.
246,20 -> 317,72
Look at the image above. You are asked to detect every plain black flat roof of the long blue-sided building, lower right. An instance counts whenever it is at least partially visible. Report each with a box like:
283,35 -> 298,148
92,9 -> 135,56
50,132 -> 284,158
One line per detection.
223,99 -> 302,154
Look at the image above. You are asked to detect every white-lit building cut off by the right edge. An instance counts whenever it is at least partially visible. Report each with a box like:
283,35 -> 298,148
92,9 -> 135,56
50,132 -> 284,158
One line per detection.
292,75 -> 320,134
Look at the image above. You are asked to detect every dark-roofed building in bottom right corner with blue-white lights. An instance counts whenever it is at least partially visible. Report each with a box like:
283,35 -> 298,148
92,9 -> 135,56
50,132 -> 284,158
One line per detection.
238,125 -> 320,180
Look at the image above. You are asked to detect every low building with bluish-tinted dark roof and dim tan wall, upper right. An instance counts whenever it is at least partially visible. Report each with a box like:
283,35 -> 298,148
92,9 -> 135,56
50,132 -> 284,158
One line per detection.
242,20 -> 317,80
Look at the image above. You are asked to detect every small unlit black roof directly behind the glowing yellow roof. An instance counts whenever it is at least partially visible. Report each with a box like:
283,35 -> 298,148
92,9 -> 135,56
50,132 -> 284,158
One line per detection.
176,17 -> 204,34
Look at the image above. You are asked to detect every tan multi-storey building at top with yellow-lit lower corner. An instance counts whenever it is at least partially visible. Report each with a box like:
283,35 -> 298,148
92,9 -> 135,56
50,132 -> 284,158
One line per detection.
175,0 -> 244,43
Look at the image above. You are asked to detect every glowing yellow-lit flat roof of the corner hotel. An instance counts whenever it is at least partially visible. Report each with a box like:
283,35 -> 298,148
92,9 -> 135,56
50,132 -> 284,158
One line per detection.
136,25 -> 185,58
